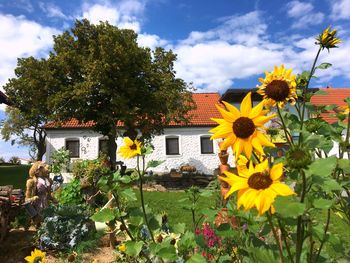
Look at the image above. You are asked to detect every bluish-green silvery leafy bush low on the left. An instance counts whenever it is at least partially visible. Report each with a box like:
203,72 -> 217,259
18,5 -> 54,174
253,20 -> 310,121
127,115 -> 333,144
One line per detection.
38,205 -> 96,251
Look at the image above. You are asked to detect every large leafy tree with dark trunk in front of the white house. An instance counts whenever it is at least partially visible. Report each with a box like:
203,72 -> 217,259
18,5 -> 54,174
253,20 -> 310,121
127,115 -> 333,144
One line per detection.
50,20 -> 194,167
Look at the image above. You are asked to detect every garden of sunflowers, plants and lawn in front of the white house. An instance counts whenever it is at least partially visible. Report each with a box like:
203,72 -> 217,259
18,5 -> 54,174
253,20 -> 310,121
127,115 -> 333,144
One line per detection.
0,23 -> 350,263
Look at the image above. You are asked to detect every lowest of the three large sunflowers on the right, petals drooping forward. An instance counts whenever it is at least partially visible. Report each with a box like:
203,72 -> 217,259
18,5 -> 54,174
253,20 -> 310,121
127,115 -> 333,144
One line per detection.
219,160 -> 294,215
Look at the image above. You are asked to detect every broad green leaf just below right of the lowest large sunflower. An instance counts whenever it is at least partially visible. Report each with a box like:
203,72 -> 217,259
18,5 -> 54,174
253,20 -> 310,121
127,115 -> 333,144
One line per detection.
273,196 -> 305,218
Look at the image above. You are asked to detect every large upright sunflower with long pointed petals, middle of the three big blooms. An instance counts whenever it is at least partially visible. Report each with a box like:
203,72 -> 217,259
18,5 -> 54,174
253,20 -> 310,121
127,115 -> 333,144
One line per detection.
209,92 -> 275,158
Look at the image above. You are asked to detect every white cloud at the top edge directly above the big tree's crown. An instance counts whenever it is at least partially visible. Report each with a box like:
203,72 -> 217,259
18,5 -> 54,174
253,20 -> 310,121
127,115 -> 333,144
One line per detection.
81,0 -> 145,32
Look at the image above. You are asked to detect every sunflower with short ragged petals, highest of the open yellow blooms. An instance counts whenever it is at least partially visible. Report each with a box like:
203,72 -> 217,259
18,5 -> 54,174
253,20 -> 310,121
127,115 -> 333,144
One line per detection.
257,65 -> 298,108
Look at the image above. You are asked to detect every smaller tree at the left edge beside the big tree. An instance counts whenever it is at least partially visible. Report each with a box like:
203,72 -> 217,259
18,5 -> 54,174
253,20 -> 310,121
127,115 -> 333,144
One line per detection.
1,57 -> 54,160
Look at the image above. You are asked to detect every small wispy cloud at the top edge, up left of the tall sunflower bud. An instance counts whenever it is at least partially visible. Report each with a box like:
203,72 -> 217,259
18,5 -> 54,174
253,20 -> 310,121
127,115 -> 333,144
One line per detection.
286,0 -> 324,28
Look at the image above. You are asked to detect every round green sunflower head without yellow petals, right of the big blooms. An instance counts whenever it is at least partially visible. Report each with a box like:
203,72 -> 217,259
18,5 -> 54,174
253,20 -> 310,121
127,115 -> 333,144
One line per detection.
286,145 -> 312,169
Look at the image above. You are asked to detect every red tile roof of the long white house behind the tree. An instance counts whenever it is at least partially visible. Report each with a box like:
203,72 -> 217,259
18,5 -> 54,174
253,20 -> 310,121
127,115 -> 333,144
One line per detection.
45,92 -> 221,129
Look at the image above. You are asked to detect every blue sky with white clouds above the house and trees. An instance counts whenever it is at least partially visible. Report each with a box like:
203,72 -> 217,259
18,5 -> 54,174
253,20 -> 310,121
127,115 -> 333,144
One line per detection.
0,0 -> 350,159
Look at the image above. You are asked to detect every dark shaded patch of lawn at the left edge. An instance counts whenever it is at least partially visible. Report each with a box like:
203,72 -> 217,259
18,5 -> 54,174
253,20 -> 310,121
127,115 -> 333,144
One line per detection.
0,165 -> 30,190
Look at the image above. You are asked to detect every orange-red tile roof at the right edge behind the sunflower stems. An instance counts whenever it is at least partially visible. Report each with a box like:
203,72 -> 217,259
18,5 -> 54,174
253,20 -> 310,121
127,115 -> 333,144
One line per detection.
311,87 -> 350,123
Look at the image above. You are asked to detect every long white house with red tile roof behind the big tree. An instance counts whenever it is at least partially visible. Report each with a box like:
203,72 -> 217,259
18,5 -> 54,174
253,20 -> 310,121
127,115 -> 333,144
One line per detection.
46,93 -> 232,174
